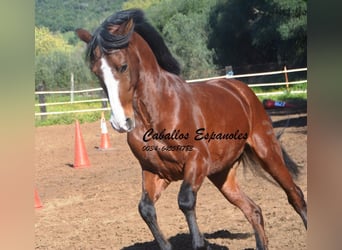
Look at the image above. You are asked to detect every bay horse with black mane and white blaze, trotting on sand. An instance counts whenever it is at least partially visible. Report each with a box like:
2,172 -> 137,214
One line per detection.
76,9 -> 307,250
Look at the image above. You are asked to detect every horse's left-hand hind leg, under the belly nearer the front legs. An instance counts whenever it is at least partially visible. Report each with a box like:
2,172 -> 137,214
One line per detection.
208,163 -> 268,250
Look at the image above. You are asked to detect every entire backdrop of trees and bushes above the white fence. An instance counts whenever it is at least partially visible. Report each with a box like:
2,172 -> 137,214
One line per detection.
35,0 -> 307,89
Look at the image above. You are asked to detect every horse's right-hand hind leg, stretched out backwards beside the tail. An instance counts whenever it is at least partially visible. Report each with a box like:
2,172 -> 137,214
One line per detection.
248,121 -> 307,228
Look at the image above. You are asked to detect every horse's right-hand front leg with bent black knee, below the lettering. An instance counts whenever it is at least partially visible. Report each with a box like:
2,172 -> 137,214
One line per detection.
178,155 -> 210,250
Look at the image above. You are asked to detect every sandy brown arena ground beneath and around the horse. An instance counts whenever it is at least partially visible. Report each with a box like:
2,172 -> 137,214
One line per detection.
35,104 -> 307,250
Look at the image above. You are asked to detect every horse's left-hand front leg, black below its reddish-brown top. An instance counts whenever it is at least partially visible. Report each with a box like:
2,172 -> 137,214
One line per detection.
139,171 -> 172,250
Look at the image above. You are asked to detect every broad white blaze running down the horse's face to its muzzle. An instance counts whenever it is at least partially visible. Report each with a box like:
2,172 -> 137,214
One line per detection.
101,57 -> 128,131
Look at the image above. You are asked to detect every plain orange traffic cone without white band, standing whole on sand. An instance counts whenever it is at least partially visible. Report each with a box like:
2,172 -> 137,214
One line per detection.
74,120 -> 90,168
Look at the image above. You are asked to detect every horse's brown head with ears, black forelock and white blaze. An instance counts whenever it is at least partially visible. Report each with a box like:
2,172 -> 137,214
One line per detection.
76,19 -> 138,132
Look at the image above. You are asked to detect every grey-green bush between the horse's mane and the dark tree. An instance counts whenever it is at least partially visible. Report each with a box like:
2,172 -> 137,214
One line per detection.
146,0 -> 215,79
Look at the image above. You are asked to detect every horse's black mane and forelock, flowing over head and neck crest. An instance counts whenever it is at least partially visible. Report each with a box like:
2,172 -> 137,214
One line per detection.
87,9 -> 181,75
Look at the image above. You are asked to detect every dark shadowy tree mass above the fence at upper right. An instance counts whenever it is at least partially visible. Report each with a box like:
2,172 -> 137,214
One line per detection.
209,0 -> 307,72
